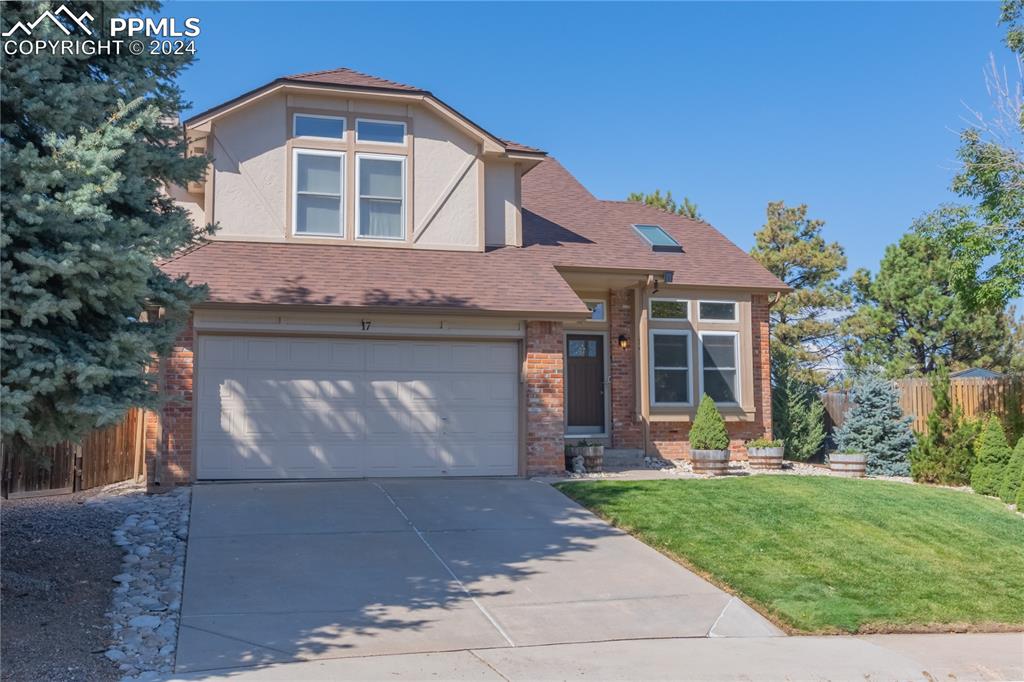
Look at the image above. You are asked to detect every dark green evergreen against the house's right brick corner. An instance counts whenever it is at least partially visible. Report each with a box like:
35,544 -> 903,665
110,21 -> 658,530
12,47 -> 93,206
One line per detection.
771,353 -> 825,462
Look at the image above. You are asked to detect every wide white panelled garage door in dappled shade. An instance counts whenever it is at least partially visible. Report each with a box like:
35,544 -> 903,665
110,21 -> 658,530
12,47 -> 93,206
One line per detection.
196,336 -> 519,479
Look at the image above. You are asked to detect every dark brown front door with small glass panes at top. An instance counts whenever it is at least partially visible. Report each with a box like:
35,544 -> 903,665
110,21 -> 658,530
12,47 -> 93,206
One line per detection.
565,334 -> 604,432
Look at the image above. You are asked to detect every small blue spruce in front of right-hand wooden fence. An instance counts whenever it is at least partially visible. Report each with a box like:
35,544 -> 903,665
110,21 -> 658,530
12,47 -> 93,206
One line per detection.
836,374 -> 914,476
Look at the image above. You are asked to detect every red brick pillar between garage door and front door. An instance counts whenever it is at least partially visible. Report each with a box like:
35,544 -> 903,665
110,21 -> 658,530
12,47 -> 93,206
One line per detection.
524,322 -> 565,475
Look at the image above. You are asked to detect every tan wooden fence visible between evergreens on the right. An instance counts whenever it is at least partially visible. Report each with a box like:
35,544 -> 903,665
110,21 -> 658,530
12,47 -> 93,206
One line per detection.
821,377 -> 1024,433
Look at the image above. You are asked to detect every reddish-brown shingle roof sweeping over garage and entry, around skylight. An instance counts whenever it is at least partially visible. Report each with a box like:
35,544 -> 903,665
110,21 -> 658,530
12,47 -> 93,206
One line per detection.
162,159 -> 785,318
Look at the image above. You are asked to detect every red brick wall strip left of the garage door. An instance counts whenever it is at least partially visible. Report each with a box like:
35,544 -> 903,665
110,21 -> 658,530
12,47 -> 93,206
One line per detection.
145,321 -> 194,492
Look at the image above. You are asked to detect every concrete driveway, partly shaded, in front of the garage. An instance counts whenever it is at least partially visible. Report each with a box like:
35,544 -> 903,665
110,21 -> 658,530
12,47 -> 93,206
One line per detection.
177,479 -> 781,672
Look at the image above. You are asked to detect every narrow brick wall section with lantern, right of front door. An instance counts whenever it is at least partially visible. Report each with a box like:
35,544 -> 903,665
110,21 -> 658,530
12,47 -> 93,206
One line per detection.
608,289 -> 643,447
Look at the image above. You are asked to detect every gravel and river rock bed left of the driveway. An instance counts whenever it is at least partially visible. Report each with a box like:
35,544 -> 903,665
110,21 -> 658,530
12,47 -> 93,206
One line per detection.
0,483 -> 189,682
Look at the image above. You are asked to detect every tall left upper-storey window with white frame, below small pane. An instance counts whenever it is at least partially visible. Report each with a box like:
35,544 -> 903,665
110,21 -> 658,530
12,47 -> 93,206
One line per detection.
292,150 -> 345,237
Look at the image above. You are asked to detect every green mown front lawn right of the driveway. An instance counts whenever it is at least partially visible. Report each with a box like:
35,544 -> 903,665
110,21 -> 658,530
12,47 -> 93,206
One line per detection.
558,476 -> 1024,632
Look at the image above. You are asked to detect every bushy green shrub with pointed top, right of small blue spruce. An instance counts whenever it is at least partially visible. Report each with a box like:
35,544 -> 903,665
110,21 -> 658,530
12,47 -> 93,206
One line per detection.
910,371 -> 981,485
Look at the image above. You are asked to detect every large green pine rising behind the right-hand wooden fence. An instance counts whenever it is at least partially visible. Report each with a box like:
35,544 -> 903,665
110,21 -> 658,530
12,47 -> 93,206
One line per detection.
845,207 -> 1010,378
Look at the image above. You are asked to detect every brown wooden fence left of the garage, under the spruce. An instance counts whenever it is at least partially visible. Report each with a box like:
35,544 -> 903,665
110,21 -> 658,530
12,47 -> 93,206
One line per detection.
0,408 -> 145,498
